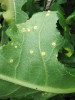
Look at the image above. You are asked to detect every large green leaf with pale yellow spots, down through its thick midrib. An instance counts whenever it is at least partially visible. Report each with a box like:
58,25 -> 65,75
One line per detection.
0,11 -> 75,93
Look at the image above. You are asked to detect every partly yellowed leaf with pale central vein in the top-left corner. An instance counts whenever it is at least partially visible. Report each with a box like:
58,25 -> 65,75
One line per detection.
0,0 -> 28,24
